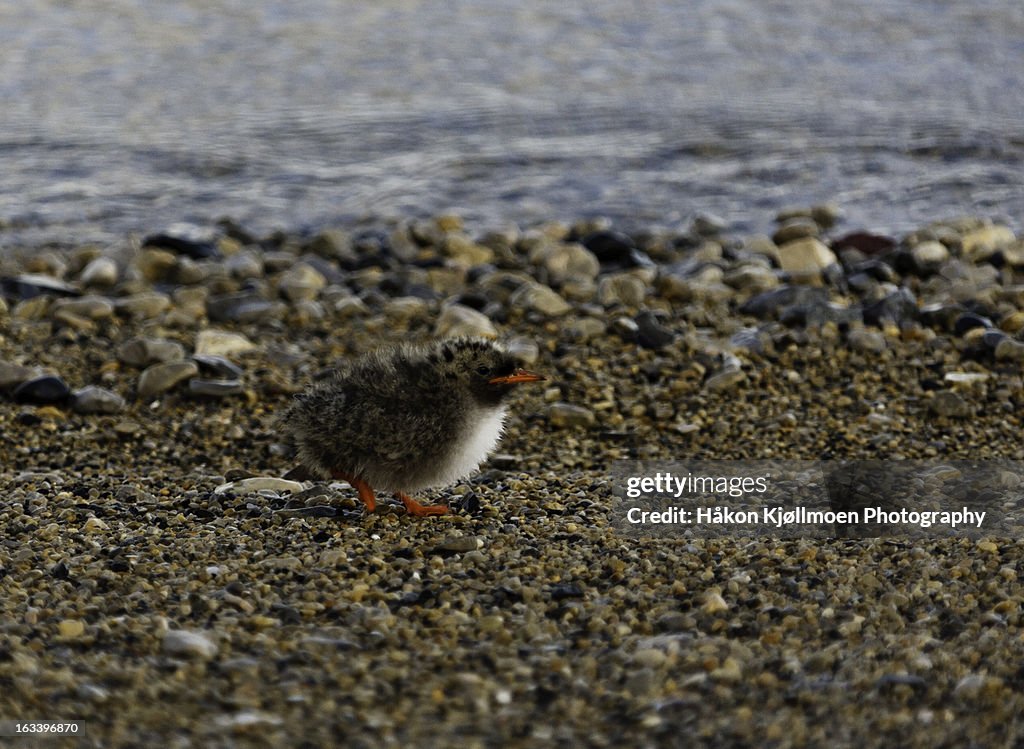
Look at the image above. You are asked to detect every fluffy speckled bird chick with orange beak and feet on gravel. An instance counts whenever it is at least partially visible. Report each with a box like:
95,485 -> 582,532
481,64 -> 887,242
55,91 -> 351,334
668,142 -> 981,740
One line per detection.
281,338 -> 545,515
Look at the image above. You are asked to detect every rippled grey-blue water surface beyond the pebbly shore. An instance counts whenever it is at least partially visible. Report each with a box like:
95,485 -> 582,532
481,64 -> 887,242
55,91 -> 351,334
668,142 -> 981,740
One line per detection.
0,0 -> 1024,248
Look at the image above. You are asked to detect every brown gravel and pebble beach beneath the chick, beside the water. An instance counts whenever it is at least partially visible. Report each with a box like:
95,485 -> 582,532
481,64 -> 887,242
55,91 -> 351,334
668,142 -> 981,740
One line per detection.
0,206 -> 1024,749
